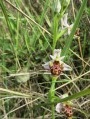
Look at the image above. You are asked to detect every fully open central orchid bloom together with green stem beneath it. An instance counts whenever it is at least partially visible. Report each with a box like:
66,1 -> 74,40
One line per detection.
42,49 -> 72,119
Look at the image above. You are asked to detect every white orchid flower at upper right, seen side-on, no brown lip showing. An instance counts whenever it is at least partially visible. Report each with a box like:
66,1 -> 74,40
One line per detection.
61,13 -> 73,35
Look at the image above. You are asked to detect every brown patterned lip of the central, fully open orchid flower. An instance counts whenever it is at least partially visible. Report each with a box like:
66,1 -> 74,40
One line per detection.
50,61 -> 63,76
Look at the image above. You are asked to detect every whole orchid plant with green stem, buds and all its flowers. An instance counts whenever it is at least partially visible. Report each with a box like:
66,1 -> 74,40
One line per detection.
42,0 -> 73,119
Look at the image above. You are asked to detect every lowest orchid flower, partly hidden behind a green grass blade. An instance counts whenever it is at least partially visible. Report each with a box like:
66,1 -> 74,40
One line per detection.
56,94 -> 73,117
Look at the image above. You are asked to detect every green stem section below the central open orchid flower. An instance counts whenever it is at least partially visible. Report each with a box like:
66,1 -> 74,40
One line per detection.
49,77 -> 57,119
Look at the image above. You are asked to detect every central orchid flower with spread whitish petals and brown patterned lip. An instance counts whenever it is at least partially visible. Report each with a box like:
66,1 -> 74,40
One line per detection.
42,49 -> 72,76
